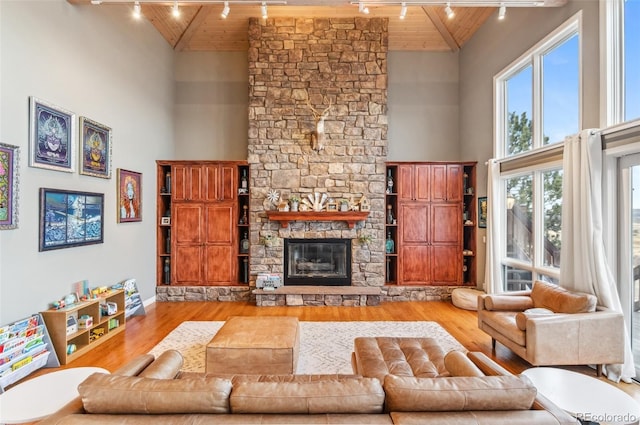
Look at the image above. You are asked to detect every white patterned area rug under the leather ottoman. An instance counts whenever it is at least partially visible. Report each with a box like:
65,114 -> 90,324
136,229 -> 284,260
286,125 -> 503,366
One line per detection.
149,321 -> 467,374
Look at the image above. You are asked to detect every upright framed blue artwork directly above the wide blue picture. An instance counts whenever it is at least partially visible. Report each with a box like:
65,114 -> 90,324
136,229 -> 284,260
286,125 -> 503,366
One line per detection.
29,96 -> 76,173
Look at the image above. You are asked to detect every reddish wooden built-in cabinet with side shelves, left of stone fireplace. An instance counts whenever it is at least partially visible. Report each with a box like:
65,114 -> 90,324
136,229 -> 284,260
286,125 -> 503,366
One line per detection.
157,161 -> 249,286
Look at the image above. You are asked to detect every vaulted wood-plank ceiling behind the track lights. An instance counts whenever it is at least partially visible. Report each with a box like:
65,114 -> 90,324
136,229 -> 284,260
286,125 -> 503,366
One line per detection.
67,0 -> 567,52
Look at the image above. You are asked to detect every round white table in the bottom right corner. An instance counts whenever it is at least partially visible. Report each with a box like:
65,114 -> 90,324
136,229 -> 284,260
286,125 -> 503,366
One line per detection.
522,367 -> 640,424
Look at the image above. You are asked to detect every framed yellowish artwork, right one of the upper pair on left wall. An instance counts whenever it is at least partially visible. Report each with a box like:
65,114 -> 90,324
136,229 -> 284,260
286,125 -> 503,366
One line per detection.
80,117 -> 111,179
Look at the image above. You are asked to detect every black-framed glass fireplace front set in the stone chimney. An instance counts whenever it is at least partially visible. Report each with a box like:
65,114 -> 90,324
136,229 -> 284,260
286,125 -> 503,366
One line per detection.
284,239 -> 351,286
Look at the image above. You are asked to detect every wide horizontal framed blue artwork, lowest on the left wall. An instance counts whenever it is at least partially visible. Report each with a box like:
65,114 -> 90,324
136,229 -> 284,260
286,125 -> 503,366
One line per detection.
39,188 -> 104,251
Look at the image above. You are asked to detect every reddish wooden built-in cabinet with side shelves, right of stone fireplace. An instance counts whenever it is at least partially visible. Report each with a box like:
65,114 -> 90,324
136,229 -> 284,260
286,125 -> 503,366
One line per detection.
385,163 -> 475,285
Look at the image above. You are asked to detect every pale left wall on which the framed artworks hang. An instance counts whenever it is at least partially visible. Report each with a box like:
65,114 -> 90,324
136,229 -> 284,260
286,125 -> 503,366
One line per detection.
0,0 -> 174,323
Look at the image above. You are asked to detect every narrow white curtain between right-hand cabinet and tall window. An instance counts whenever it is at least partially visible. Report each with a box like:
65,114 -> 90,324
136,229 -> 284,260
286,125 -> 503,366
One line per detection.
484,159 -> 503,294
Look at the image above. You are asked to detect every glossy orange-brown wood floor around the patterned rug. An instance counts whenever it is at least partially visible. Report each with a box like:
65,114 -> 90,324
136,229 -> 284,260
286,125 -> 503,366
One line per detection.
22,301 -> 640,416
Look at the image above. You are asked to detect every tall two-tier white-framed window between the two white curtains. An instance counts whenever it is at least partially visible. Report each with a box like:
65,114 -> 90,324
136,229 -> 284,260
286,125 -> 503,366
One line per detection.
494,14 -> 576,291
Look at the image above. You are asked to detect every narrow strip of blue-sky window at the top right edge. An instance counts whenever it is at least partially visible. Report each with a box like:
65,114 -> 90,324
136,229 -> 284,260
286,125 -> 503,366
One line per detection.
623,0 -> 640,121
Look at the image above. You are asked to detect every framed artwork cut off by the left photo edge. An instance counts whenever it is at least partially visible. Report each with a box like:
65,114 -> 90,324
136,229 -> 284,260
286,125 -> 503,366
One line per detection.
0,143 -> 20,230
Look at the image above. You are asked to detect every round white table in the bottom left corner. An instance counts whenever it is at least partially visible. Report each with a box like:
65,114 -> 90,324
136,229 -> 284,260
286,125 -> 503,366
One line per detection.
0,367 -> 109,424
